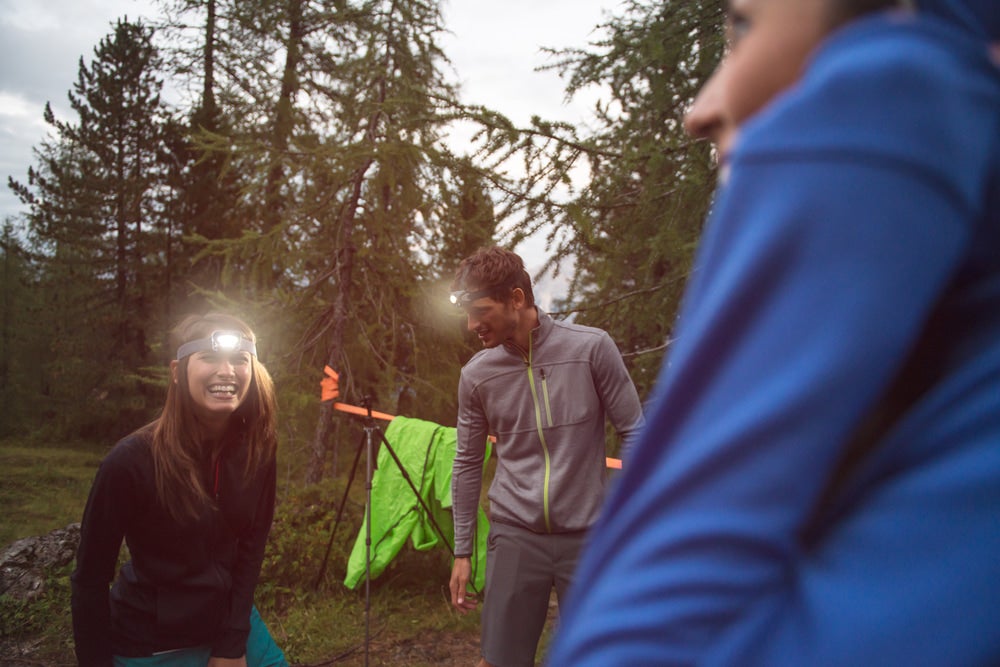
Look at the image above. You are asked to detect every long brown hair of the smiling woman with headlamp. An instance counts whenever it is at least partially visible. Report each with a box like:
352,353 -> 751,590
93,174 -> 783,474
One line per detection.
151,313 -> 278,521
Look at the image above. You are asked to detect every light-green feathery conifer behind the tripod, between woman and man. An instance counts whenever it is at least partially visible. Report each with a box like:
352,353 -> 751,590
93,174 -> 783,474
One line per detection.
294,0 -> 492,481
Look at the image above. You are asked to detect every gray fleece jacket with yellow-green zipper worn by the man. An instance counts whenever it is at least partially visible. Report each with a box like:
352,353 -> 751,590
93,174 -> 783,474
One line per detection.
452,310 -> 643,557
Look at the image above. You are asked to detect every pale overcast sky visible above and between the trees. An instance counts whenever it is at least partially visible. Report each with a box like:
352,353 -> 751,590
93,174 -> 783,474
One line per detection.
0,0 -> 618,224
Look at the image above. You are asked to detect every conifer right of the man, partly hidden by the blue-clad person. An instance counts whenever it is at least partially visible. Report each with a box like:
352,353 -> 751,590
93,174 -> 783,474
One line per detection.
520,0 -> 723,395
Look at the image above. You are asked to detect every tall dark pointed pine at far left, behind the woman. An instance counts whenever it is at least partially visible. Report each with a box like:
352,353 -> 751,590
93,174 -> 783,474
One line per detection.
11,19 -> 176,432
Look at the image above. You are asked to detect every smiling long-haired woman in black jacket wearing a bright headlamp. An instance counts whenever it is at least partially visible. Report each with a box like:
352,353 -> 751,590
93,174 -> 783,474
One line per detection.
72,313 -> 287,667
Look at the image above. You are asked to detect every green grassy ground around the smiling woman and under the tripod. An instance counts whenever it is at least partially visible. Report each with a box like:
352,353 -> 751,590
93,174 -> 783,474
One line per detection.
0,439 -> 490,667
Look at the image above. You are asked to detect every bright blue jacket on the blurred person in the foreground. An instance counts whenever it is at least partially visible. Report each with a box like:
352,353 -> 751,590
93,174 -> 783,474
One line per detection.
549,5 -> 1000,667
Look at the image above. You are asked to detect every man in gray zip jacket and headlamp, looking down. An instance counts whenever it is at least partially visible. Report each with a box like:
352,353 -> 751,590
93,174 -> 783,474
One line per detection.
450,247 -> 643,667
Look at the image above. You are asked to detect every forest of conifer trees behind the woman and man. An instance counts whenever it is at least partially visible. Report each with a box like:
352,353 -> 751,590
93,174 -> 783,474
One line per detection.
0,0 -> 724,662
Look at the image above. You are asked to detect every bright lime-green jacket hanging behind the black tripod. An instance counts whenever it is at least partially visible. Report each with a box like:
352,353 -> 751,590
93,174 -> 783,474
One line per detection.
344,417 -> 490,591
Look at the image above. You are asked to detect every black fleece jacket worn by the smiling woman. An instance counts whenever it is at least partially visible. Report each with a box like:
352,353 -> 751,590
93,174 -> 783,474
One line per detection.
72,427 -> 275,667
